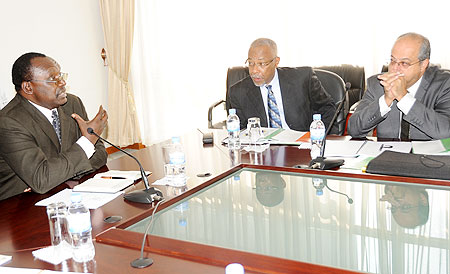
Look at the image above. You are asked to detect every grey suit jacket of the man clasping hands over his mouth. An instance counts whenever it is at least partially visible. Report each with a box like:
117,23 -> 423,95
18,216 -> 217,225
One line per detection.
348,66 -> 450,140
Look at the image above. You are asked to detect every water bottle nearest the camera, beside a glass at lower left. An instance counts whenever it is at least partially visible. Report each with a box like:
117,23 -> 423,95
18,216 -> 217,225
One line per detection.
68,193 -> 95,262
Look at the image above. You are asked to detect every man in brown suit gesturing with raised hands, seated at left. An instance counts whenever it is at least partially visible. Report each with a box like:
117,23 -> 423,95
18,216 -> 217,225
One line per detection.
0,53 -> 108,200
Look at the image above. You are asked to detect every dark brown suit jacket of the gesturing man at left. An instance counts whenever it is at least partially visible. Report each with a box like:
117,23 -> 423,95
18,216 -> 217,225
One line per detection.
0,94 -> 107,200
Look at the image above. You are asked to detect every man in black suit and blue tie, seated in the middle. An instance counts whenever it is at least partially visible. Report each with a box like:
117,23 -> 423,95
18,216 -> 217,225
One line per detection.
227,38 -> 336,131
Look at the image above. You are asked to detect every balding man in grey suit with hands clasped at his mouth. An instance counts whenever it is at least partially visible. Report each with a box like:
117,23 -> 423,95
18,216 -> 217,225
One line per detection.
348,33 -> 450,140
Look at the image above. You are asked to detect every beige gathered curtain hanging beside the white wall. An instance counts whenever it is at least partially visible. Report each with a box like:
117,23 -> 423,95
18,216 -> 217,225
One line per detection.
99,0 -> 141,146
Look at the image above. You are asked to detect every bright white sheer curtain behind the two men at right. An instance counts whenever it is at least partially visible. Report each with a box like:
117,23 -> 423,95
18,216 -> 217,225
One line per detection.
131,0 -> 450,144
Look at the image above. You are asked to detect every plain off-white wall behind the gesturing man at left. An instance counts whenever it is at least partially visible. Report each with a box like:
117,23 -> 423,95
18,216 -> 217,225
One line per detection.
0,0 -> 108,118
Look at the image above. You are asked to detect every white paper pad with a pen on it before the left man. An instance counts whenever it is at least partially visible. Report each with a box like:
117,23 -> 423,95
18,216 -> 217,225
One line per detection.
73,170 -> 152,193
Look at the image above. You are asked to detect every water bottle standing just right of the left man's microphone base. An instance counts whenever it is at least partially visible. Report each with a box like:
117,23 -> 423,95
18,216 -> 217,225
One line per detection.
169,136 -> 186,186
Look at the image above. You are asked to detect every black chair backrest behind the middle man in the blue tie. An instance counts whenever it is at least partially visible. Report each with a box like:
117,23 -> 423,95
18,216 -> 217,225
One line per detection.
226,66 -> 349,135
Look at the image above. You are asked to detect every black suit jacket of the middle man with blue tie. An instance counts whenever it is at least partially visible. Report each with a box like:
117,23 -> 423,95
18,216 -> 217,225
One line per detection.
227,67 -> 336,131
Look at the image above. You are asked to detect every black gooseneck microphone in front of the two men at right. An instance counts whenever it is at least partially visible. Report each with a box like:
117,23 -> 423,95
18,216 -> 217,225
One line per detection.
309,82 -> 352,170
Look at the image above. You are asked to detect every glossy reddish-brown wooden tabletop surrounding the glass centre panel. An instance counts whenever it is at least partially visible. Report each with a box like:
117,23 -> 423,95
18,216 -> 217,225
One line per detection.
0,130 -> 448,273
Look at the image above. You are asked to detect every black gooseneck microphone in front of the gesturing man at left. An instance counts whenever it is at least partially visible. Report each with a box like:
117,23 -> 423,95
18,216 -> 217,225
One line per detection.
87,127 -> 163,204
